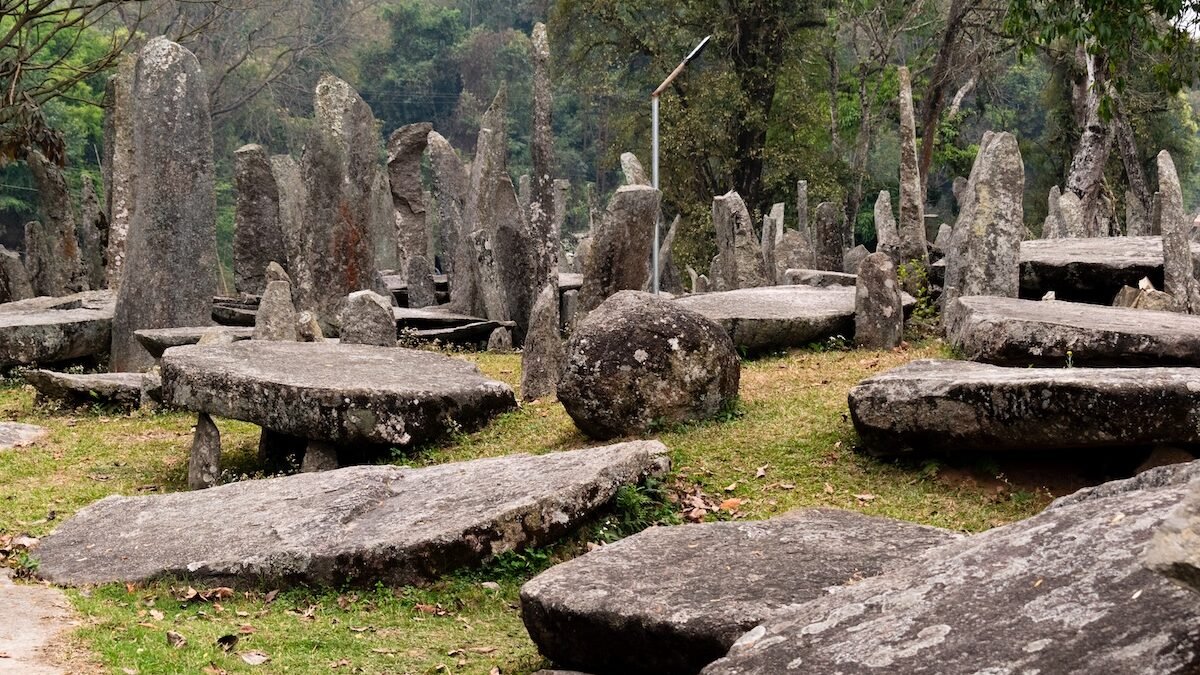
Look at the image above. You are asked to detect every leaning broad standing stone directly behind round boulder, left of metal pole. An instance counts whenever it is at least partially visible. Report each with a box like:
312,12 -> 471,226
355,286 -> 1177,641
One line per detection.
580,185 -> 661,313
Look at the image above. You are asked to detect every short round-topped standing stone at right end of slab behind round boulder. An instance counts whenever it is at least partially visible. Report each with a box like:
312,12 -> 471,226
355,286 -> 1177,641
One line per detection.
854,252 -> 904,350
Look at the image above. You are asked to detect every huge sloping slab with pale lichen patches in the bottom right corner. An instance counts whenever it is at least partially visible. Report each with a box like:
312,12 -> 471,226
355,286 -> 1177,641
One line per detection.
703,462 -> 1200,675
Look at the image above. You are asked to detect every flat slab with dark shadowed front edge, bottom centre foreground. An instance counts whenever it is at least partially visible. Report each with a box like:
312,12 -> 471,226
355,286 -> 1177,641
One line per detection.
521,509 -> 959,675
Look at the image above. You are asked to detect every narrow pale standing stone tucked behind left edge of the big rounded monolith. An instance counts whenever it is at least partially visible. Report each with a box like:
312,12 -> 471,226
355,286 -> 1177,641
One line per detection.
104,56 -> 136,289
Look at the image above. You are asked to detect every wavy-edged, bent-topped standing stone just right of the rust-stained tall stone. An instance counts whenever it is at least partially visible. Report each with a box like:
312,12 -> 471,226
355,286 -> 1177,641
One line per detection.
388,121 -> 433,277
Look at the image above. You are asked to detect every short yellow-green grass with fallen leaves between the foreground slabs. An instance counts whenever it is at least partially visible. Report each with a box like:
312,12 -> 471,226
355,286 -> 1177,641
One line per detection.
0,342 -> 1050,674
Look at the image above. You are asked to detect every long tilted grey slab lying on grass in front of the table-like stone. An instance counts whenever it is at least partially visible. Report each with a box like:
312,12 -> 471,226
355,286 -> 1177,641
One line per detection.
35,439 -> 670,586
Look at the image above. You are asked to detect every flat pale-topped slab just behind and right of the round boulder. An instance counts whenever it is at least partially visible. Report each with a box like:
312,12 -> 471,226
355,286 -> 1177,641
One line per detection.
674,286 -> 916,353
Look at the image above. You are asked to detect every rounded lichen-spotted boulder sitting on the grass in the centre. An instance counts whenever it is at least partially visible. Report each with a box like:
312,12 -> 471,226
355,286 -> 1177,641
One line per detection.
558,291 -> 742,438
